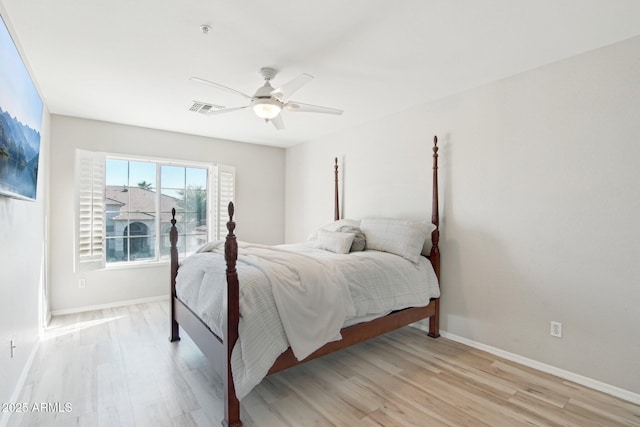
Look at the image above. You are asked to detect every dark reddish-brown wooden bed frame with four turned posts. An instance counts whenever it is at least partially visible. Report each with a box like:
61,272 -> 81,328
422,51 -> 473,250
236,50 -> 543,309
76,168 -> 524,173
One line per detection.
170,137 -> 440,427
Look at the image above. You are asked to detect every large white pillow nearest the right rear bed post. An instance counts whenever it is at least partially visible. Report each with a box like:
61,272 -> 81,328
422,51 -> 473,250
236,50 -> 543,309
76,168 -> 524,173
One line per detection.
360,218 -> 435,263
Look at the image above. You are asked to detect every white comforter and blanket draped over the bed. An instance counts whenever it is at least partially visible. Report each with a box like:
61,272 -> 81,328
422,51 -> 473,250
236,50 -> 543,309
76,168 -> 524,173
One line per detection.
176,242 -> 439,399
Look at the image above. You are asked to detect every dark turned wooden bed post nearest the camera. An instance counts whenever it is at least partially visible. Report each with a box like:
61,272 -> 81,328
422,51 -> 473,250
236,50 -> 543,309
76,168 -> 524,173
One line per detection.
222,202 -> 242,427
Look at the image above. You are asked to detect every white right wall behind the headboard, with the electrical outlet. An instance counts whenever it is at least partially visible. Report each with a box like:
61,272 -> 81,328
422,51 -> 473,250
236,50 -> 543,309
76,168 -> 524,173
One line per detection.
285,38 -> 640,393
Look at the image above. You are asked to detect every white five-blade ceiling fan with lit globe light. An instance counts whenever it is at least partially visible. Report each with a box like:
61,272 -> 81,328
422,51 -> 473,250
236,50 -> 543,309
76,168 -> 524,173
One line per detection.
189,67 -> 343,130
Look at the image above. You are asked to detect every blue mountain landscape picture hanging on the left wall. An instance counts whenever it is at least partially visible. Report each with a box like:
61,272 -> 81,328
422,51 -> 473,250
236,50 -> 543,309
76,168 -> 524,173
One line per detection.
0,16 -> 43,200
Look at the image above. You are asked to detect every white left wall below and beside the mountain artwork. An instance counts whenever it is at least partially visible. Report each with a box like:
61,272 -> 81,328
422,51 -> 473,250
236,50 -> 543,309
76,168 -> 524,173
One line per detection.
0,4 -> 50,414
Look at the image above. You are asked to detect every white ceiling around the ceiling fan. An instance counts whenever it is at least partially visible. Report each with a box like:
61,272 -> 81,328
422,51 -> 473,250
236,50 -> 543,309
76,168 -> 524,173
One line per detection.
0,0 -> 640,147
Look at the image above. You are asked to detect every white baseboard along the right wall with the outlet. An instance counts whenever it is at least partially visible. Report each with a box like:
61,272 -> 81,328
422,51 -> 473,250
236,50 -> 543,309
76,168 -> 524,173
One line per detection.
412,323 -> 640,405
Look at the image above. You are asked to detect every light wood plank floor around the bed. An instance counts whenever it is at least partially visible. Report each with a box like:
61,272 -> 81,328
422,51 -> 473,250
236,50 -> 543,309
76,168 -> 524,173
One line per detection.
9,302 -> 640,427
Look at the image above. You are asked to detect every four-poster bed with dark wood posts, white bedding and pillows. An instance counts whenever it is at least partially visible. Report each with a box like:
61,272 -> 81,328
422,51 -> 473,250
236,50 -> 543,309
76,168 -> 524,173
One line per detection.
170,137 -> 440,427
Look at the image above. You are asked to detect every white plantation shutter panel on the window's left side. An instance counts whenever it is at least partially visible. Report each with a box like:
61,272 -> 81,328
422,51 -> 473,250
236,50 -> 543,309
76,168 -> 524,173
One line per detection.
75,150 -> 105,271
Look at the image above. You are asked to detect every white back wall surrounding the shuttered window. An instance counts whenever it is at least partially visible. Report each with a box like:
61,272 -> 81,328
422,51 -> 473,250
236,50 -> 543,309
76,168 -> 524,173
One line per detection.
50,115 -> 285,313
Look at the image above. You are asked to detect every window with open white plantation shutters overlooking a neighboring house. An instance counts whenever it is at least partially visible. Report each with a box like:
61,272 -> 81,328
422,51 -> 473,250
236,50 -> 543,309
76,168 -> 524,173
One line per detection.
76,150 -> 235,270
